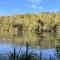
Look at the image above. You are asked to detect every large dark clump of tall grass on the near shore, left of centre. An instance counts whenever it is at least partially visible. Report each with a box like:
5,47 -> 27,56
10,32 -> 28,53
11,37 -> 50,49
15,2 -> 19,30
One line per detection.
9,43 -> 39,60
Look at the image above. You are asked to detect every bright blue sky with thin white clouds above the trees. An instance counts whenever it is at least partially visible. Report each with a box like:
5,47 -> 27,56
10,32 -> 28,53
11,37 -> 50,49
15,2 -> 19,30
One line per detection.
0,0 -> 60,15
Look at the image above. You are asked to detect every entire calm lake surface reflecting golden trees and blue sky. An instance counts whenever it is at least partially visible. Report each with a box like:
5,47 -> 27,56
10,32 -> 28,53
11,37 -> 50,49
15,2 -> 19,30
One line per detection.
0,31 -> 60,58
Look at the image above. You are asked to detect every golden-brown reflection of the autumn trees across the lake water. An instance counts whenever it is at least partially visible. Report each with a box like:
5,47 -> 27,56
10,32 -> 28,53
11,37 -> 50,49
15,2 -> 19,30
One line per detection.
0,32 -> 60,48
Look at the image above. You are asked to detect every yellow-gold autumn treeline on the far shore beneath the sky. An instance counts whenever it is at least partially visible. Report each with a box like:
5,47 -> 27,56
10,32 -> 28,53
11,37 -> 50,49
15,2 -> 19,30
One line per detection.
0,12 -> 60,32
